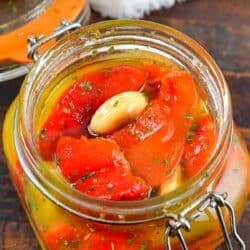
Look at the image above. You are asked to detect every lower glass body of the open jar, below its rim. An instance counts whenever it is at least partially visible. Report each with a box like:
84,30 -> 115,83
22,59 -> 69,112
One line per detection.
3,98 -> 250,250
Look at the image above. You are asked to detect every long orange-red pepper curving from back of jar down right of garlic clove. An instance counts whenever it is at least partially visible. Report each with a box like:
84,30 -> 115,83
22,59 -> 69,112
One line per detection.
112,71 -> 198,187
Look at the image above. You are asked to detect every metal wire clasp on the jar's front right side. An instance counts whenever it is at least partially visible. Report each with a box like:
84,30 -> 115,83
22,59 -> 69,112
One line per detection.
165,192 -> 246,250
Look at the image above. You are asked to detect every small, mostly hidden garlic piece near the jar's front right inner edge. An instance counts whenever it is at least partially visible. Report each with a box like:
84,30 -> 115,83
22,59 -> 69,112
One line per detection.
159,165 -> 183,195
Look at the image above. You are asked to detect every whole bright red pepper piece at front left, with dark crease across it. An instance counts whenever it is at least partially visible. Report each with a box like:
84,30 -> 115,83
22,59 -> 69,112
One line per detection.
56,136 -> 151,200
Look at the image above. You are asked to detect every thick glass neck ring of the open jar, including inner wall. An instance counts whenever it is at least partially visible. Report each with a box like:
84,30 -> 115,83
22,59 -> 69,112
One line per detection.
14,20 -> 232,224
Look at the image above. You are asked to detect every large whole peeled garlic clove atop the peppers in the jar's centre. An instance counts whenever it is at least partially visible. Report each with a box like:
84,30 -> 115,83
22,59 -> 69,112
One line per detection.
89,91 -> 148,135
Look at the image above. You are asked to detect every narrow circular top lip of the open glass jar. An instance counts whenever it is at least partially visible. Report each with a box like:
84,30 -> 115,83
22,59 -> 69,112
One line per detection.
14,20 -> 232,224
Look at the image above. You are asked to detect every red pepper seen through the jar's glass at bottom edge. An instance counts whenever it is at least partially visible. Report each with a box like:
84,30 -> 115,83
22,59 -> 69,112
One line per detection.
43,223 -> 150,250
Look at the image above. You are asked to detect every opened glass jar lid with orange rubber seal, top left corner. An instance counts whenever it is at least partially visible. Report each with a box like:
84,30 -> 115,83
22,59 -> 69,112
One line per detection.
0,0 -> 89,82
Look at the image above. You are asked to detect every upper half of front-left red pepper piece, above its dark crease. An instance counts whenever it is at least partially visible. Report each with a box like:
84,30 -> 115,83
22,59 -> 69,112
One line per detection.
56,136 -> 129,183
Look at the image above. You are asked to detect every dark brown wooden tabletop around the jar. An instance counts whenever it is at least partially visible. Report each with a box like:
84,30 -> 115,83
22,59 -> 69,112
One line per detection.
0,0 -> 250,250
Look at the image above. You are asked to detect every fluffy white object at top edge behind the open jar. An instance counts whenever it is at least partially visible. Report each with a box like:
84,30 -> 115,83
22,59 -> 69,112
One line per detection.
90,0 -> 185,18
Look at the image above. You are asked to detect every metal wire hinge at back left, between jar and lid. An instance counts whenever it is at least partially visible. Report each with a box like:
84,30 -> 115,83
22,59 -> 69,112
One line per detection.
27,20 -> 81,61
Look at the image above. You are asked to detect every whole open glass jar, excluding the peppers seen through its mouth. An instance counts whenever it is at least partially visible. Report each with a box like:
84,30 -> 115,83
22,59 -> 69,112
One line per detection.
3,20 -> 250,250
